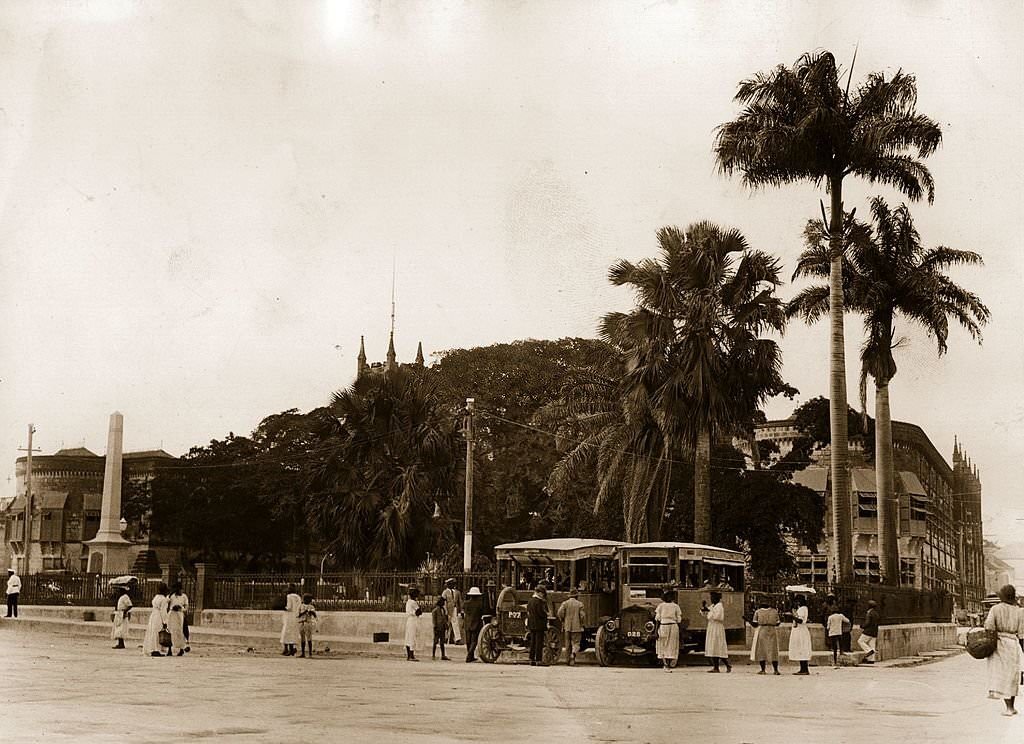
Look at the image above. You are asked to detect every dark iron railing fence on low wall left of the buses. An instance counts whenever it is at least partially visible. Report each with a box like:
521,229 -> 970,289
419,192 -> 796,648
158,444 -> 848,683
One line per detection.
205,571 -> 495,612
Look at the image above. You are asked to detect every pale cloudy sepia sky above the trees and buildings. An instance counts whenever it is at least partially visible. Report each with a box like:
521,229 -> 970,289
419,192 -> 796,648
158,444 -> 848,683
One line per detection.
0,0 -> 1024,542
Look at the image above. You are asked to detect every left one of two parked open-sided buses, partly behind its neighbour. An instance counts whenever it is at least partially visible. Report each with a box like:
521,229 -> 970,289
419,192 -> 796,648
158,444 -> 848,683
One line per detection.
477,537 -> 626,663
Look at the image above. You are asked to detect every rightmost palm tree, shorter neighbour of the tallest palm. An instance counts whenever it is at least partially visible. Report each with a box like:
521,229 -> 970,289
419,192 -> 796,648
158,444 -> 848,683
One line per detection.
786,196 -> 989,584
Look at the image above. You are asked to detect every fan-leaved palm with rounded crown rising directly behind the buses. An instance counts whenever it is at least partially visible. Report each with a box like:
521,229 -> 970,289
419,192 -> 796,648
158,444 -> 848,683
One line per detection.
601,222 -> 787,542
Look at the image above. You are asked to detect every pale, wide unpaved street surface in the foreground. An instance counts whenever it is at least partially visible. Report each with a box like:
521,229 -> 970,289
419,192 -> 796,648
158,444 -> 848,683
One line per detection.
0,621 -> 1024,744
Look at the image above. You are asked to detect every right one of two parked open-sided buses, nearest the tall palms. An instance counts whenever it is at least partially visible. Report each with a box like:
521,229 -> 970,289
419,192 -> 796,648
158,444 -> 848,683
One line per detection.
595,542 -> 744,665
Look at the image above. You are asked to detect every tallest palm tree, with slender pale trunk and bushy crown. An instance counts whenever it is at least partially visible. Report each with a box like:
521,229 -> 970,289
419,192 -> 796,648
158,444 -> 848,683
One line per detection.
715,51 -> 942,581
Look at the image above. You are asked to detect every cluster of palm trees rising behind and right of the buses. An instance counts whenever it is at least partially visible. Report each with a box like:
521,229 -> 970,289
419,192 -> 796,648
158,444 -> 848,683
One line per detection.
553,51 -> 988,583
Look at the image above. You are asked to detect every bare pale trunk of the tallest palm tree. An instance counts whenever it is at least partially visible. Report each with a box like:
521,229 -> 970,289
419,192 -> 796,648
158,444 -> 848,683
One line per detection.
828,176 -> 853,583
